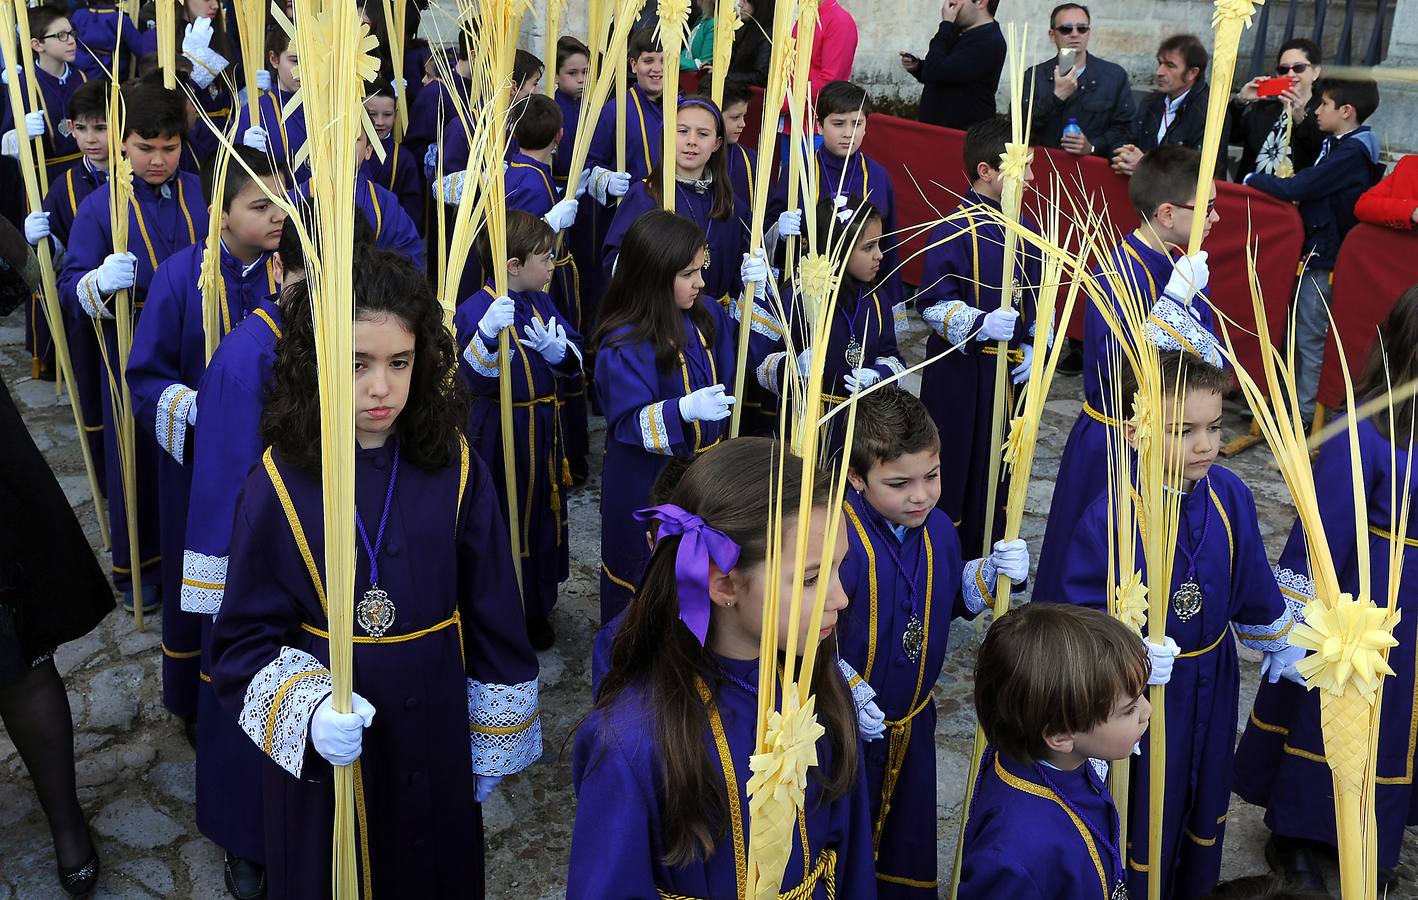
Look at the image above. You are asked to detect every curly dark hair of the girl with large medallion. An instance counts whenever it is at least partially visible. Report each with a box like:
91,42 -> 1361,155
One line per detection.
261,249 -> 468,472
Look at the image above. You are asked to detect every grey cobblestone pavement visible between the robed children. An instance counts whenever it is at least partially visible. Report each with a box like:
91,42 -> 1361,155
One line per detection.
0,307 -> 1418,900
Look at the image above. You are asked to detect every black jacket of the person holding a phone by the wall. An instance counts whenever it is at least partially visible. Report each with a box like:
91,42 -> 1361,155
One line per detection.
912,21 -> 1005,129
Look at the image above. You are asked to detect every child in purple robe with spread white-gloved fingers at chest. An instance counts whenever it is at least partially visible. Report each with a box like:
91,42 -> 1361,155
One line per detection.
452,209 -> 581,651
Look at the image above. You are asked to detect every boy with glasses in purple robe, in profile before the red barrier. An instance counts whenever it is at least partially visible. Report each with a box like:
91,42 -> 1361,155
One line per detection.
1034,145 -> 1224,600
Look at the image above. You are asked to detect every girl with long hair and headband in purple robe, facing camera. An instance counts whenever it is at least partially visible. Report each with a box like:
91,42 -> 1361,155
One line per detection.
601,96 -> 767,306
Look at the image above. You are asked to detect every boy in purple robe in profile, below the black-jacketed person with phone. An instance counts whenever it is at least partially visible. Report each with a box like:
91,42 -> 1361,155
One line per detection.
916,116 -> 1041,553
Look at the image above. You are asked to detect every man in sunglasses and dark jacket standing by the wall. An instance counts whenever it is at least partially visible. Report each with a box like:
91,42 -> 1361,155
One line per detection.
1028,3 -> 1133,157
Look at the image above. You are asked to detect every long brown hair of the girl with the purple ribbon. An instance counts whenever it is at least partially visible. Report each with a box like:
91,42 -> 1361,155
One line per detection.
596,438 -> 858,866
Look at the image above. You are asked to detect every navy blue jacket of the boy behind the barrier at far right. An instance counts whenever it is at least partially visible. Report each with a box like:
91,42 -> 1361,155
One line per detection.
1245,125 -> 1384,269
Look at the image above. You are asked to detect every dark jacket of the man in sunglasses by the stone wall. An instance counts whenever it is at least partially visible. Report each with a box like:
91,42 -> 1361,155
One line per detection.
1029,54 -> 1134,157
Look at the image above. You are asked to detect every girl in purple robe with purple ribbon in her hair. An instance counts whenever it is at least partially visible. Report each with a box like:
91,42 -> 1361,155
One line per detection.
567,438 -> 876,900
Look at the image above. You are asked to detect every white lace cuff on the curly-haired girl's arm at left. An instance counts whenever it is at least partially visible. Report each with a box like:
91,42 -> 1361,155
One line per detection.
237,646 -> 333,778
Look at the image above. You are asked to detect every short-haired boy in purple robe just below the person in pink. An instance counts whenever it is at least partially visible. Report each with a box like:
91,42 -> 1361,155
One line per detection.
767,81 -> 902,303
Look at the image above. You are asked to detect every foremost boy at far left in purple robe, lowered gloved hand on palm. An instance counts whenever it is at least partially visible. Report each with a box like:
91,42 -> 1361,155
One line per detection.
60,84 -> 207,637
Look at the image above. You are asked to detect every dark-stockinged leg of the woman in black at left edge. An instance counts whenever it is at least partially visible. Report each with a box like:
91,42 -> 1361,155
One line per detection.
0,659 -> 94,869
